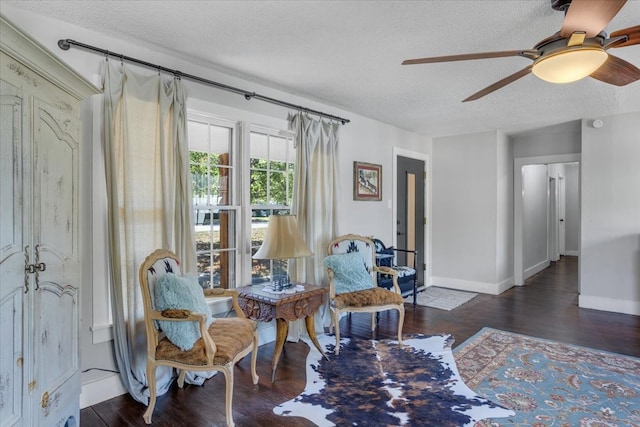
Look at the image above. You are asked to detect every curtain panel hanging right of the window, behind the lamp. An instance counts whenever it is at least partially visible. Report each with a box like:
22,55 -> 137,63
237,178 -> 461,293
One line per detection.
288,113 -> 340,341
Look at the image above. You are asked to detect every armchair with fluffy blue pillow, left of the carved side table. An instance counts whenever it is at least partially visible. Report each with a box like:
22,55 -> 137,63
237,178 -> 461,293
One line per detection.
140,249 -> 258,426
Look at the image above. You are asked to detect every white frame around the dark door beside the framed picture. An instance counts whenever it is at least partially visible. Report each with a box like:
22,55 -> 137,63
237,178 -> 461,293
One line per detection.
389,147 -> 431,286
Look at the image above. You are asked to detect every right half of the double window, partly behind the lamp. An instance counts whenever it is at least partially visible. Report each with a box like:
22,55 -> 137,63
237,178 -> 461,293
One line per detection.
249,127 -> 295,283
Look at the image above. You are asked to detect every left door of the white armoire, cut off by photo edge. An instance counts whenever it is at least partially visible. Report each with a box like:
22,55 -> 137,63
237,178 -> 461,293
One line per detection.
0,82 -> 29,425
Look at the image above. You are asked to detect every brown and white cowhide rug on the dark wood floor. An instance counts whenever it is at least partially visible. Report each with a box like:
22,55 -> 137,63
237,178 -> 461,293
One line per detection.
273,335 -> 514,427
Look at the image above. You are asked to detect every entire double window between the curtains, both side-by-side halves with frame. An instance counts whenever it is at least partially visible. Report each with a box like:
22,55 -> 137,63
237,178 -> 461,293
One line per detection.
188,112 -> 295,289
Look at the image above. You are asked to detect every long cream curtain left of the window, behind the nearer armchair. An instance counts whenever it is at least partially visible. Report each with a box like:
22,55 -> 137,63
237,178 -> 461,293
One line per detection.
103,61 -> 198,404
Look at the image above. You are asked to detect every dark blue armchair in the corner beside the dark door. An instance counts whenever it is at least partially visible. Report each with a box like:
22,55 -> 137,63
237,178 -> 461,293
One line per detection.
371,238 -> 418,306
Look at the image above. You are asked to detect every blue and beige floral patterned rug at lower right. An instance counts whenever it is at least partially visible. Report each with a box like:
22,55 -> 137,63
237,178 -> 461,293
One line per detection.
454,328 -> 640,427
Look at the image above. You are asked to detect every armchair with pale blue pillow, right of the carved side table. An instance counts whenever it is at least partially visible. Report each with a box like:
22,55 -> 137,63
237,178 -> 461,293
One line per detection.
324,234 -> 404,354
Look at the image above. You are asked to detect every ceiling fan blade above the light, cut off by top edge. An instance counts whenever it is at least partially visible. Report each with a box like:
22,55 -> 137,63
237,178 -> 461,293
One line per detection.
560,0 -> 627,37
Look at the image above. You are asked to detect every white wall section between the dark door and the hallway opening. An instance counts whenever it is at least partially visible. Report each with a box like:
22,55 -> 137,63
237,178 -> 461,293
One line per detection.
432,132 -> 512,294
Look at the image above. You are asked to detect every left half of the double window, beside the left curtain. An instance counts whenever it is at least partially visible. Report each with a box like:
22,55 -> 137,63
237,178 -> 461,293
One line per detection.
188,114 -> 240,289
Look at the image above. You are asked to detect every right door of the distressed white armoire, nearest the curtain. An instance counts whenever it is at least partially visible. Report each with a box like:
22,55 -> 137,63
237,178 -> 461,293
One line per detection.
33,99 -> 80,414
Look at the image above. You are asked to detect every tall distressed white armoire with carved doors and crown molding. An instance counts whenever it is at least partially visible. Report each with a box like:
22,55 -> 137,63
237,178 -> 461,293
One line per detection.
0,16 -> 98,426
